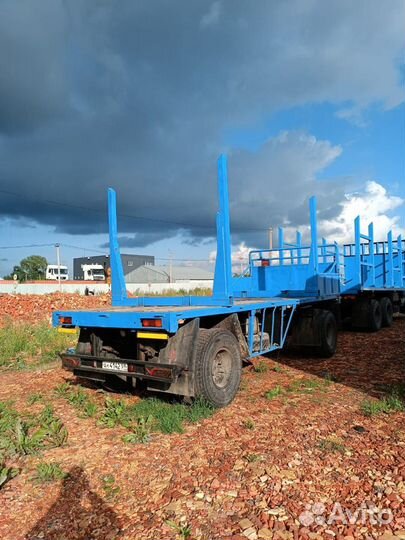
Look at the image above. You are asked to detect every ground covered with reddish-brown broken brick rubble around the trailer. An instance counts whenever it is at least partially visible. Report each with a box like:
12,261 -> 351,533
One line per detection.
0,297 -> 405,540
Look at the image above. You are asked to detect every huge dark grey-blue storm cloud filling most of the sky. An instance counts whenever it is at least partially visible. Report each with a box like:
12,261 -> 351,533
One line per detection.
0,0 -> 405,247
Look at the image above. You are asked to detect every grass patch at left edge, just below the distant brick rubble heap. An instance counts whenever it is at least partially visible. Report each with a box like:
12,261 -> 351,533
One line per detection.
0,321 -> 72,369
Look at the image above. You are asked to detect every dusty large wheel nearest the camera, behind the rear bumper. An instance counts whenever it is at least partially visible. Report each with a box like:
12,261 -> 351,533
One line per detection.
195,328 -> 242,407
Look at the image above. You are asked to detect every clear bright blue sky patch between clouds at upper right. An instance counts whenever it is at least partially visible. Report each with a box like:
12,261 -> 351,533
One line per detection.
224,103 -> 405,201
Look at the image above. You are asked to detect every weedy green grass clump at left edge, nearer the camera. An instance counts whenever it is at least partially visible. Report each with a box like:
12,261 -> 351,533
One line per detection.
0,402 -> 68,457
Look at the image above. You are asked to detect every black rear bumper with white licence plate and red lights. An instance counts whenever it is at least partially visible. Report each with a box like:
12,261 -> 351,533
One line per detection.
60,353 -> 185,383
